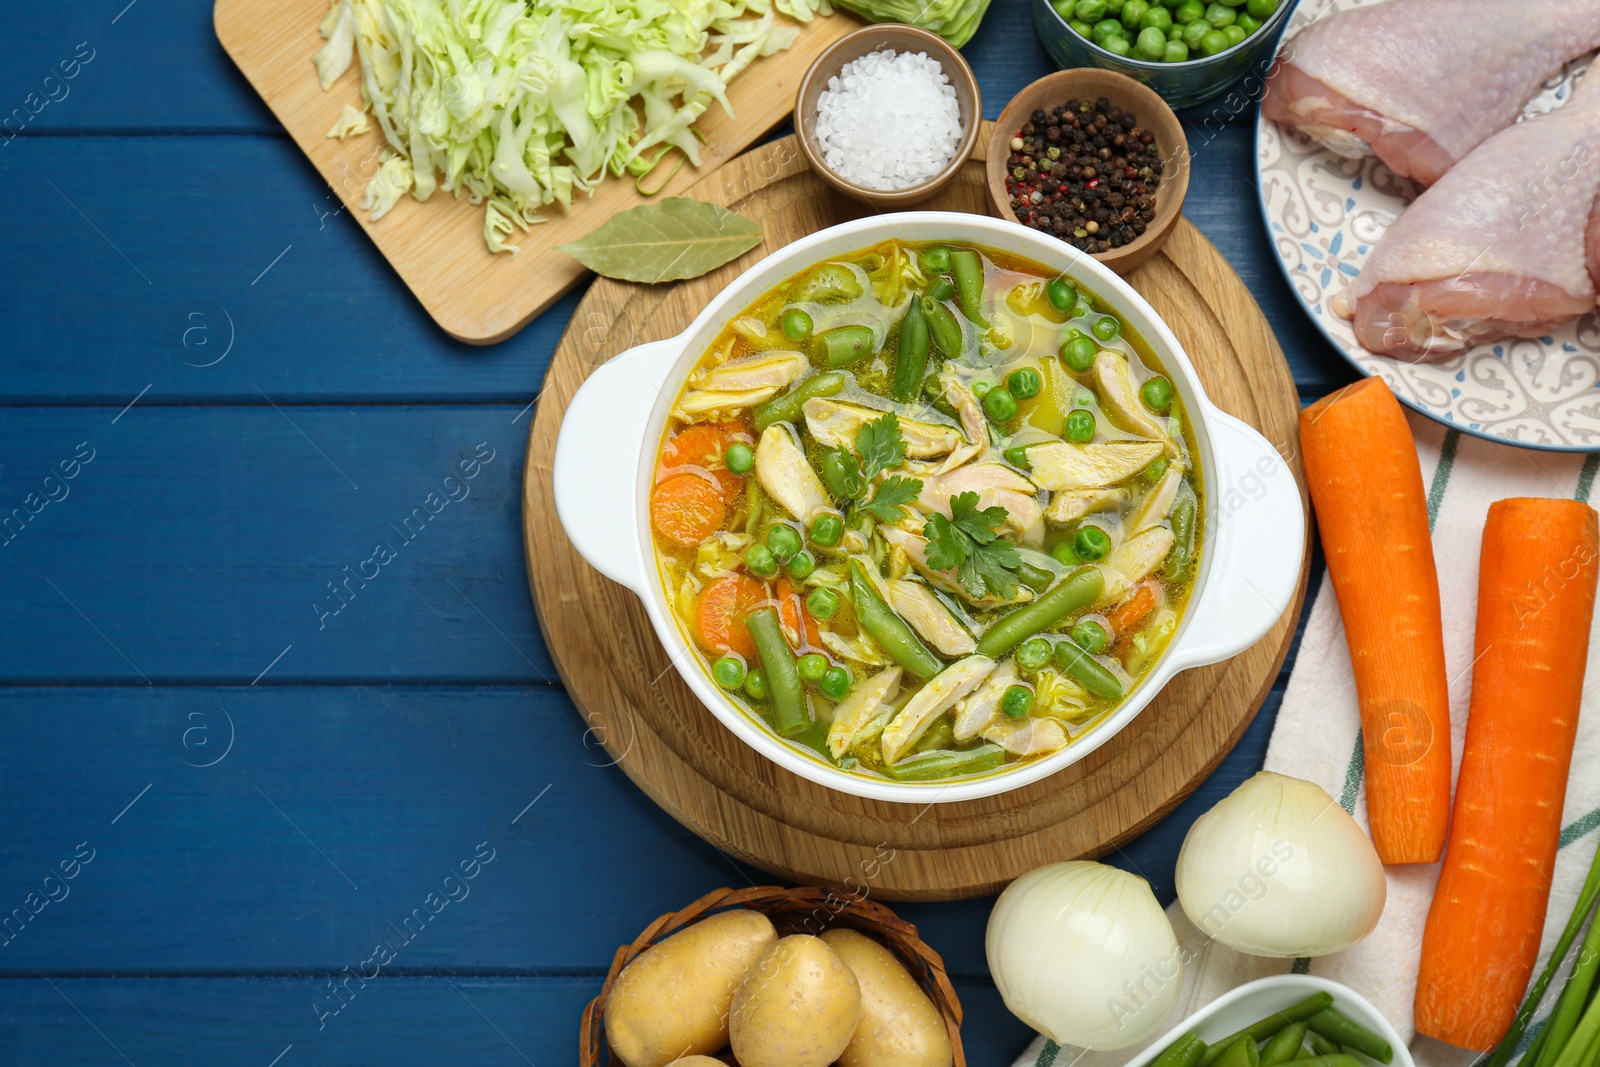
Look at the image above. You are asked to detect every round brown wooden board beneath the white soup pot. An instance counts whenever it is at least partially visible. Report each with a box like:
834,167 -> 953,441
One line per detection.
523,125 -> 1309,901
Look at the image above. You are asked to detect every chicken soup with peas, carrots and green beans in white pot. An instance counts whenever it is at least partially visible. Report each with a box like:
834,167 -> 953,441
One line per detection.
650,242 -> 1205,781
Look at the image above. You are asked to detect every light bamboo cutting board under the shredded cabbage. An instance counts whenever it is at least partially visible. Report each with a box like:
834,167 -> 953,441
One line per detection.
213,0 -> 861,344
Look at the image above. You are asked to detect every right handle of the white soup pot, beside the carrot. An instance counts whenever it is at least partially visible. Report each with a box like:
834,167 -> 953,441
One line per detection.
1173,410 -> 1306,670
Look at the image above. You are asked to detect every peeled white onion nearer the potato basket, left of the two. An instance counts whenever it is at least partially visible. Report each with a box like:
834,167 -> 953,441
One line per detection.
987,861 -> 1182,1049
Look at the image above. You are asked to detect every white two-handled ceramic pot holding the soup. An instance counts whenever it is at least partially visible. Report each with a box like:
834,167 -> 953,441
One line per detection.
554,211 -> 1306,803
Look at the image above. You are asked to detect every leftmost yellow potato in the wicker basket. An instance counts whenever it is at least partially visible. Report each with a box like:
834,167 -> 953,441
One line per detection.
605,909 -> 778,1067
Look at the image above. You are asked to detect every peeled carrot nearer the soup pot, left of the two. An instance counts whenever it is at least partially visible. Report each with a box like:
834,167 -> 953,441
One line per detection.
1301,378 -> 1450,864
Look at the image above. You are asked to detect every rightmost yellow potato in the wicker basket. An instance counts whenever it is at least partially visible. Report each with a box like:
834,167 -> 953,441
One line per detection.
822,928 -> 955,1067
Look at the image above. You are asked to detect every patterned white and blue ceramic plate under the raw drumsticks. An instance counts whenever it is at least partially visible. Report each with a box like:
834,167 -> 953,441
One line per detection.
1256,0 -> 1600,451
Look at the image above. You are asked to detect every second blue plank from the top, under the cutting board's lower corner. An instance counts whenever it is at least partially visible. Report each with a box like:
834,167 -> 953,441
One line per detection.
0,128 -> 1349,406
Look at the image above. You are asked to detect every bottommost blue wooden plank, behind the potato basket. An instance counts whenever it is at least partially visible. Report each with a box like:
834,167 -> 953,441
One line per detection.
0,976 -> 1032,1067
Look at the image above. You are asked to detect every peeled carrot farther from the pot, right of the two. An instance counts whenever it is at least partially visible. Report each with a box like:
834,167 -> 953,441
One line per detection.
1416,499 -> 1600,1051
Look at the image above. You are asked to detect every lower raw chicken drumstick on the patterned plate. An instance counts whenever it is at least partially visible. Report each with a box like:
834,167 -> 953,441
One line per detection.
1334,69 -> 1600,362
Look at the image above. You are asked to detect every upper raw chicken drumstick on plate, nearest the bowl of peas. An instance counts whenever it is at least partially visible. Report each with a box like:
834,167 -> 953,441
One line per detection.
1261,0 -> 1600,186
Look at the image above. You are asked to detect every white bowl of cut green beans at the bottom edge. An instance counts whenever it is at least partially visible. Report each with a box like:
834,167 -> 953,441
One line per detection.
1128,974 -> 1414,1067
